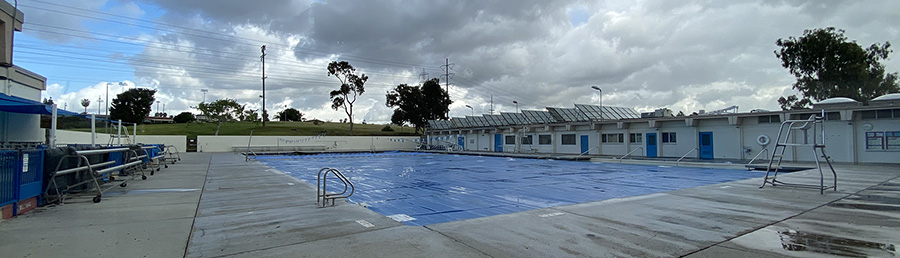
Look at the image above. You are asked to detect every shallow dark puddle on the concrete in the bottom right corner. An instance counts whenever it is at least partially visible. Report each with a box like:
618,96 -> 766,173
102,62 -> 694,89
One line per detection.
778,230 -> 897,257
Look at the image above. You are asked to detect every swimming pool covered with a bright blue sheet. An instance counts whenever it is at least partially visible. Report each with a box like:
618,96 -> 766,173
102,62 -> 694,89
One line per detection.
260,152 -> 761,226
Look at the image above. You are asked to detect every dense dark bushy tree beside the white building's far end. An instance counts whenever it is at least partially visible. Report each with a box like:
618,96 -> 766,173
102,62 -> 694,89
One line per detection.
385,78 -> 453,133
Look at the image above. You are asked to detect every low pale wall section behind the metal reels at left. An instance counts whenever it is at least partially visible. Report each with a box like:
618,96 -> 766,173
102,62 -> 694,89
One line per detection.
54,129 -> 187,152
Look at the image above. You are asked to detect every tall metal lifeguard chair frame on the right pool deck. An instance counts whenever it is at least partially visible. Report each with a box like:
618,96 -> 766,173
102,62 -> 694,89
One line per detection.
759,110 -> 837,194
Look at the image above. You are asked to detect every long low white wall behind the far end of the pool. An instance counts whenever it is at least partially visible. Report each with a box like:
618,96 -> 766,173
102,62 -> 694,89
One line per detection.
197,135 -> 419,152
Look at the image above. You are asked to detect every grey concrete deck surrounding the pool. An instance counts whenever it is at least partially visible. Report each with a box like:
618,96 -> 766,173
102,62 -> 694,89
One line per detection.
0,153 -> 900,257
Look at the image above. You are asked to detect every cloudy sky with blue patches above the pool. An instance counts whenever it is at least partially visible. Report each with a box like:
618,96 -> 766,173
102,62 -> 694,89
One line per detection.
14,0 -> 900,123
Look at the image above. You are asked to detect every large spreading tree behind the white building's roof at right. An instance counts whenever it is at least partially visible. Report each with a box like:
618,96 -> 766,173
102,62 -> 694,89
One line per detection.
775,27 -> 900,108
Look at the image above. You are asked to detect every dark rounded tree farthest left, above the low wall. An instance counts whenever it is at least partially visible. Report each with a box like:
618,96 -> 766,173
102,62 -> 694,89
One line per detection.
109,88 -> 156,124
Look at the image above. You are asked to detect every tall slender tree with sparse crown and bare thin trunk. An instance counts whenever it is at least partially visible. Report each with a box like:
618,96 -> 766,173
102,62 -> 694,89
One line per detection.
328,61 -> 369,135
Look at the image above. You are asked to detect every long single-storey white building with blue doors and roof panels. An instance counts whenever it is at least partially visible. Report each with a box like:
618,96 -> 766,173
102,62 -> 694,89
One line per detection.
426,93 -> 900,163
